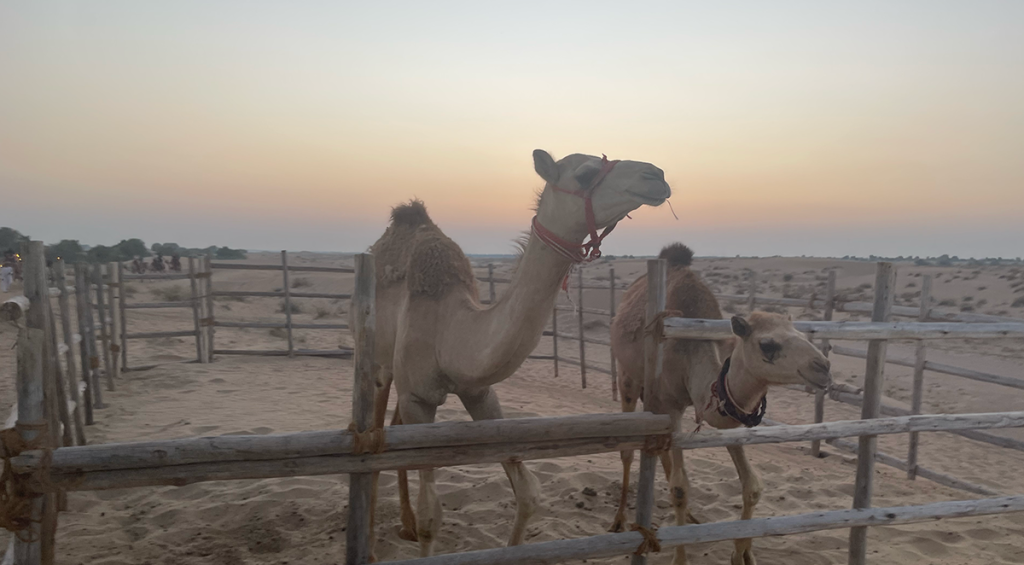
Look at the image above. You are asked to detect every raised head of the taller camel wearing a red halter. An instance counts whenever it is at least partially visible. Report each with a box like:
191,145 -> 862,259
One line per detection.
534,149 -> 672,243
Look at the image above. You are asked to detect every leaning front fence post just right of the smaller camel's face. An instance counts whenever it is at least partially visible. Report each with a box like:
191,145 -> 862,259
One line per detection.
848,262 -> 896,565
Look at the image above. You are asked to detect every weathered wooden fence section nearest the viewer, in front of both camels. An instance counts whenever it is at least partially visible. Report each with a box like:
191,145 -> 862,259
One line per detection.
3,249 -> 1024,565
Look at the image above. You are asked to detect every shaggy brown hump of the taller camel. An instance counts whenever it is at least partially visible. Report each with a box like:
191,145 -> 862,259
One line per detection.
370,200 -> 476,297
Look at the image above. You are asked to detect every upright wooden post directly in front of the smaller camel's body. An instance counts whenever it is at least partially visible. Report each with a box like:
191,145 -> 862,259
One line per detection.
632,259 -> 668,565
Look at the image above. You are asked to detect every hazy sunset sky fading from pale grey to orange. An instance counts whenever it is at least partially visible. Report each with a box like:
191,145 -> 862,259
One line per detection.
0,0 -> 1024,257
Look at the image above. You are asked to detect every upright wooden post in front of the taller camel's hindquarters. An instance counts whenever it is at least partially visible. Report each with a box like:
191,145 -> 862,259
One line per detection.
345,253 -> 377,565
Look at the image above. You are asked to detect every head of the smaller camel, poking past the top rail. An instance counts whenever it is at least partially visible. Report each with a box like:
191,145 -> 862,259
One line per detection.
732,312 -> 831,389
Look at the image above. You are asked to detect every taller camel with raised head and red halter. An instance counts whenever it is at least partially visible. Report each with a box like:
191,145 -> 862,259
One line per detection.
362,149 -> 671,556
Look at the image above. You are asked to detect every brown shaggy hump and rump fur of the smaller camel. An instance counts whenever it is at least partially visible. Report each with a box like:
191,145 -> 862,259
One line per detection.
611,244 -> 722,341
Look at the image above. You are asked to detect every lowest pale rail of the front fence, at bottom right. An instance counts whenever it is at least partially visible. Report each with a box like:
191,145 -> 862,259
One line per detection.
387,496 -> 1024,565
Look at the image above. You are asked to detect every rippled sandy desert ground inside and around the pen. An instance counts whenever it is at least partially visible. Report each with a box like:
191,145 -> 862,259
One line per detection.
0,254 -> 1024,565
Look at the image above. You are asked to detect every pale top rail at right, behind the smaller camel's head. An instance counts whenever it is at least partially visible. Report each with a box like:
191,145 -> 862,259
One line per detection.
659,317 -> 1024,340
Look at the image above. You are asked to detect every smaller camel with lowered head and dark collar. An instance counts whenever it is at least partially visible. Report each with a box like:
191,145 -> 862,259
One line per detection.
609,244 -> 831,565
